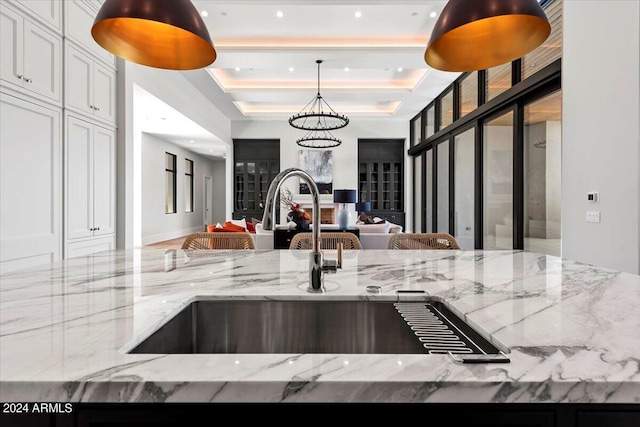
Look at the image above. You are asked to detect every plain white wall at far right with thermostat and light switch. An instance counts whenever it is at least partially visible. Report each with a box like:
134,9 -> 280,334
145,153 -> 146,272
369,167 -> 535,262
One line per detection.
562,0 -> 640,273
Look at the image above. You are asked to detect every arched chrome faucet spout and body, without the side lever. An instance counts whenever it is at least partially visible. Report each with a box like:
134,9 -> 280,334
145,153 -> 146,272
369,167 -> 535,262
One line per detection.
262,168 -> 325,292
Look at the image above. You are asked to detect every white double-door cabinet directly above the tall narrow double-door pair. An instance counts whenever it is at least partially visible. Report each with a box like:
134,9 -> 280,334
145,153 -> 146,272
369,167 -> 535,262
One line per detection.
65,43 -> 116,124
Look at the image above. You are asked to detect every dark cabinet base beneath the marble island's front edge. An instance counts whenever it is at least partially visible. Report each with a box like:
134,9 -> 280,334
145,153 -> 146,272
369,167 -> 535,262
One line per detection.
0,403 -> 640,427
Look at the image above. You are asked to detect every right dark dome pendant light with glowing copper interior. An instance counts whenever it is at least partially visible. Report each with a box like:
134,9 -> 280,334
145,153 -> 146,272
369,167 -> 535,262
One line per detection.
424,0 -> 551,71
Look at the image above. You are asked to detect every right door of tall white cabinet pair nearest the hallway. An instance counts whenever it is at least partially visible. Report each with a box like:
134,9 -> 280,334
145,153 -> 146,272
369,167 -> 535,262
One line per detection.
93,126 -> 116,236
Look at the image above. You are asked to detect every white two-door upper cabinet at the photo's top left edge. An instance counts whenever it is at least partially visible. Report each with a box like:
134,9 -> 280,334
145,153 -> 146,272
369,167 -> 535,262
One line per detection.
0,4 -> 62,103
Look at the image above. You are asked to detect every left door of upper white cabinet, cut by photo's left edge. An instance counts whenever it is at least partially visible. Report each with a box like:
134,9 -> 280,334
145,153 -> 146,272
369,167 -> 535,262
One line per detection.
0,5 -> 24,87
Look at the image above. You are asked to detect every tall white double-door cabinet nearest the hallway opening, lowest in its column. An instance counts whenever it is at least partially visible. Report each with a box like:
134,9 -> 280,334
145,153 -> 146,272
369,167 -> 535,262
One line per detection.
65,116 -> 116,246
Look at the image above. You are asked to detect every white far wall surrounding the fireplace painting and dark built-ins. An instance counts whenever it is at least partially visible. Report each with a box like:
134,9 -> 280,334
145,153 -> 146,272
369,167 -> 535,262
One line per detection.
231,117 -> 413,227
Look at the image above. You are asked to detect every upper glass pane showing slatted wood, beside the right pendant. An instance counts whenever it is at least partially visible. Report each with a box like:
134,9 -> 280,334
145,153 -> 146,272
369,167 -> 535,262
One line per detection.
522,0 -> 563,80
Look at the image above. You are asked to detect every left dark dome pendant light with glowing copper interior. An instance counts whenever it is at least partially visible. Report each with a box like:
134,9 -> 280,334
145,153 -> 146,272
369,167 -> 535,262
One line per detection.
91,0 -> 217,70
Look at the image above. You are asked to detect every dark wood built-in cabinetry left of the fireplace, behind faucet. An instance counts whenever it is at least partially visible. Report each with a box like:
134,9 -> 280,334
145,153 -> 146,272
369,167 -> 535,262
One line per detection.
232,139 -> 280,221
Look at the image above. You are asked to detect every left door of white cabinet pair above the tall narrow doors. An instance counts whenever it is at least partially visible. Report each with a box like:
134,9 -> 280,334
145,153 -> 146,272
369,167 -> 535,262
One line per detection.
65,44 -> 94,115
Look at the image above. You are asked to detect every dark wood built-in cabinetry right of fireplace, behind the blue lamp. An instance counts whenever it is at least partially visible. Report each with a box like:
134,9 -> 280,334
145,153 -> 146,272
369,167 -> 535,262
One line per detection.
358,139 -> 405,227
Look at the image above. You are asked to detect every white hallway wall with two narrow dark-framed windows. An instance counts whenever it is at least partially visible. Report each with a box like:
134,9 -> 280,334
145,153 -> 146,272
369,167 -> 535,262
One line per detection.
141,133 -> 224,244
